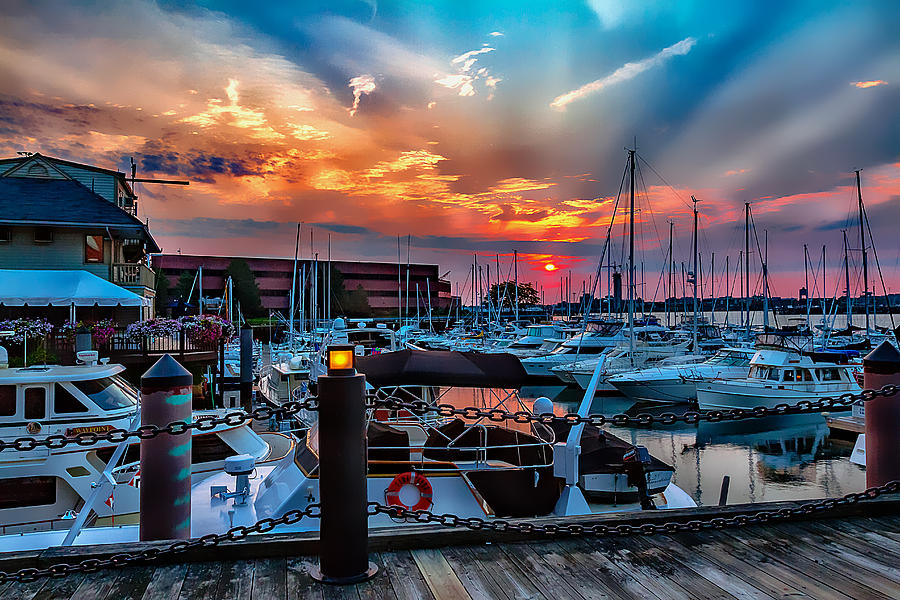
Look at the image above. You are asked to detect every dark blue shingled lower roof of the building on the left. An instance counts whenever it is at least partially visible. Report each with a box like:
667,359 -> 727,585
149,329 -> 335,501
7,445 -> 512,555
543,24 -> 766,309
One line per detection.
0,177 -> 160,252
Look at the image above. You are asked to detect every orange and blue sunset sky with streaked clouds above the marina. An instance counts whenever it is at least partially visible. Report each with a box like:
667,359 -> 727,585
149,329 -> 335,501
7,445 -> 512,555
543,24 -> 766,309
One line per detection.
0,0 -> 900,300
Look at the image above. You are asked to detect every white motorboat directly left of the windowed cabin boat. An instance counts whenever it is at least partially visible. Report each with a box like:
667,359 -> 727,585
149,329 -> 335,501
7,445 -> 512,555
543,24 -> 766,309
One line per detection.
607,348 -> 756,403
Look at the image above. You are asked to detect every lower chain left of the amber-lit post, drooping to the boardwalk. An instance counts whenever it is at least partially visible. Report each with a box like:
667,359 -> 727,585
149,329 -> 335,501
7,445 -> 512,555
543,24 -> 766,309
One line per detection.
0,504 -> 322,584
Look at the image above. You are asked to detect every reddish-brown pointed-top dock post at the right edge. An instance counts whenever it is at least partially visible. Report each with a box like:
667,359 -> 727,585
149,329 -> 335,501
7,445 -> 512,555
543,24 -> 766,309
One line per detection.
863,341 -> 900,487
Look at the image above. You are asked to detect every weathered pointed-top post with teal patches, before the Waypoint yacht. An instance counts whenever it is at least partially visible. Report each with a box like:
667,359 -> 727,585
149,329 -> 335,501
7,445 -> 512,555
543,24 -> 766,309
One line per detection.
140,354 -> 194,542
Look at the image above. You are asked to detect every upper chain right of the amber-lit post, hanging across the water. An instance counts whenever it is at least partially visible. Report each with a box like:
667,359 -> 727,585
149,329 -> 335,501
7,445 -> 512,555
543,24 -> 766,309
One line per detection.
366,384 -> 900,427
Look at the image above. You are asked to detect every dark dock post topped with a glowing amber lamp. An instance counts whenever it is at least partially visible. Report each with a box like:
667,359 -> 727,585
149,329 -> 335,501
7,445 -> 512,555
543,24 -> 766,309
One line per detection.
310,345 -> 378,585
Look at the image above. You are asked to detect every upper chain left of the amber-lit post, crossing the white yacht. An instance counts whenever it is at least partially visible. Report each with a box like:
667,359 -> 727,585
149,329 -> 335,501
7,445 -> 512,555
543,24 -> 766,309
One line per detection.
0,397 -> 319,451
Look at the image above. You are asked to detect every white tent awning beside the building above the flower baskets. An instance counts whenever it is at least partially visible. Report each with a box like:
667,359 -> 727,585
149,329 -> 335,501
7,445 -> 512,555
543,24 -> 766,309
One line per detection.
0,269 -> 145,306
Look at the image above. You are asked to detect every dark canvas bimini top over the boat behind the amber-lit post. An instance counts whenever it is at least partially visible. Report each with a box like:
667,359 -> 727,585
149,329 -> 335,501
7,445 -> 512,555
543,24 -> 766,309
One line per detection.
356,350 -> 528,389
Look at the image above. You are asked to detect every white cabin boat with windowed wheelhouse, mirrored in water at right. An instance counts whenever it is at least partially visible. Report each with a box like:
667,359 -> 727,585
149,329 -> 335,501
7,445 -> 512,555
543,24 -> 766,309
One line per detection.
696,349 -> 862,410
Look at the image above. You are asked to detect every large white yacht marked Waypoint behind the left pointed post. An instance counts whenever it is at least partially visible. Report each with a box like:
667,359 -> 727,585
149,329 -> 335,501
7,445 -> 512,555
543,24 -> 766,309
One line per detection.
0,352 -> 293,534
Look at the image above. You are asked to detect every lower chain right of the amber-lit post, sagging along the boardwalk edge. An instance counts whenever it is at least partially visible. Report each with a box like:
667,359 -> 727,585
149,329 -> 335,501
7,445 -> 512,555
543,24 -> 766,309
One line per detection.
367,481 -> 900,536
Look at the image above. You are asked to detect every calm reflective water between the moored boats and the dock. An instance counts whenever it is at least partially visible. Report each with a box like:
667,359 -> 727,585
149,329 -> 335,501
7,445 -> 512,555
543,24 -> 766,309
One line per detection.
441,386 -> 866,505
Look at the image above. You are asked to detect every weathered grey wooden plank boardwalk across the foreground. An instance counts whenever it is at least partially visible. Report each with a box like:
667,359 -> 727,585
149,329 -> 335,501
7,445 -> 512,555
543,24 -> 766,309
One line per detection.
0,494 -> 900,600
